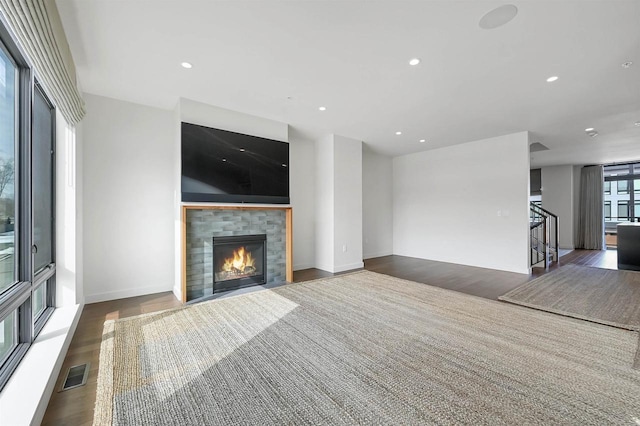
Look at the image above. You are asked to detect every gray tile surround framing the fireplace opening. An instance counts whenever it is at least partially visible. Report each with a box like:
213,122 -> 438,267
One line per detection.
185,209 -> 286,301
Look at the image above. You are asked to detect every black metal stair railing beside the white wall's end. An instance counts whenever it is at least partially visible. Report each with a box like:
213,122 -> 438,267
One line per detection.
529,203 -> 559,269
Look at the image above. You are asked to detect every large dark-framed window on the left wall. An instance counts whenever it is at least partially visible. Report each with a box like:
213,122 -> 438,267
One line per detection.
0,23 -> 56,391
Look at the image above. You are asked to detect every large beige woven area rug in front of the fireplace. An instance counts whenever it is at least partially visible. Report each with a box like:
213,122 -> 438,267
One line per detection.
94,271 -> 640,425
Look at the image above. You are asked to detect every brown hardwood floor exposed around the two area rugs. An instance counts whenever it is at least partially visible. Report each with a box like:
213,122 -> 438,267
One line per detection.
42,250 -> 616,426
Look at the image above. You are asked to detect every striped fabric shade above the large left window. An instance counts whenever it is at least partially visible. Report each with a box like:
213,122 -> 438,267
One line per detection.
0,0 -> 85,125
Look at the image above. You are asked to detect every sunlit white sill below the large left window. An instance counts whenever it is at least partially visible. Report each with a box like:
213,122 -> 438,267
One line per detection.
0,305 -> 82,425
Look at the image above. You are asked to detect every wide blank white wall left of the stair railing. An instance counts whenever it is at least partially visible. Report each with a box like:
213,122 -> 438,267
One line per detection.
393,132 -> 529,274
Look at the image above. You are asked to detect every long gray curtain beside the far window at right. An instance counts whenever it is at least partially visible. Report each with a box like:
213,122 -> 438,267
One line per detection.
577,166 -> 604,250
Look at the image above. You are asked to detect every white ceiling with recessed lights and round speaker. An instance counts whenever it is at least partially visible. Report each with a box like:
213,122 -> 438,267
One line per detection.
56,0 -> 640,166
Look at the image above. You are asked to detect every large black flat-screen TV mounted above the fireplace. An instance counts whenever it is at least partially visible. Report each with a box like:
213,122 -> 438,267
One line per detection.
181,122 -> 289,204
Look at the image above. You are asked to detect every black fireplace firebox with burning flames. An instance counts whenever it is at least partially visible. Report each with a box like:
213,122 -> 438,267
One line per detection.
213,234 -> 267,293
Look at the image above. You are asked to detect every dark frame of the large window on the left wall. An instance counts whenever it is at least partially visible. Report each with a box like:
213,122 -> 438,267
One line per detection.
0,20 -> 56,391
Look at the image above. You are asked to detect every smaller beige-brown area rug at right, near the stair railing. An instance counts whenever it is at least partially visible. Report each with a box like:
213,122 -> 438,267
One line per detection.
499,265 -> 640,330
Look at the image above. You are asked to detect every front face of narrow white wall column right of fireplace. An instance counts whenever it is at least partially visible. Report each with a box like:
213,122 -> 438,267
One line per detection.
332,135 -> 364,272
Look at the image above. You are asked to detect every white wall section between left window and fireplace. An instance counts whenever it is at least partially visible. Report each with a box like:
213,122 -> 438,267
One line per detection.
82,94 -> 176,302
